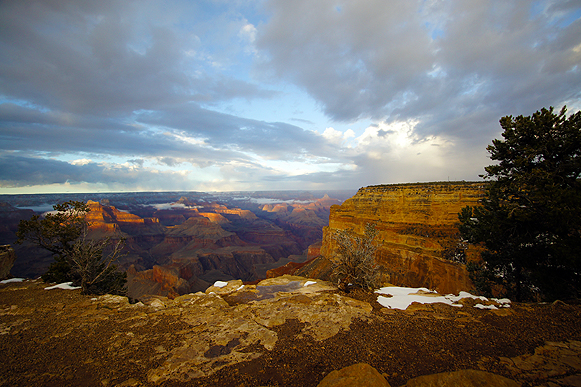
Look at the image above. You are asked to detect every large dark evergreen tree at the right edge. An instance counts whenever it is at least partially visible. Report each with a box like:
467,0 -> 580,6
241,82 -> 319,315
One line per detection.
459,107 -> 581,300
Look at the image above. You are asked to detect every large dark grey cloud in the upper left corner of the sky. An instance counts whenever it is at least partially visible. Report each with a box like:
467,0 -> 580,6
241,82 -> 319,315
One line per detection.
0,0 -> 272,115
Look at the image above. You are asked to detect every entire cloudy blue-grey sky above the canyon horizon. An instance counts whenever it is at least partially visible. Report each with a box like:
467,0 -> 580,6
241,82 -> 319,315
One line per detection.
0,0 -> 581,193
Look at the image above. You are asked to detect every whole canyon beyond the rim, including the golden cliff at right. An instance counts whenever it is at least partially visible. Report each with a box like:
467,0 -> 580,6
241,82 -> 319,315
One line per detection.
3,182 -> 484,298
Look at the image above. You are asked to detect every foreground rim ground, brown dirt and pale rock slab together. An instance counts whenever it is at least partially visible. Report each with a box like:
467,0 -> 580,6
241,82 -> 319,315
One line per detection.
0,276 -> 581,386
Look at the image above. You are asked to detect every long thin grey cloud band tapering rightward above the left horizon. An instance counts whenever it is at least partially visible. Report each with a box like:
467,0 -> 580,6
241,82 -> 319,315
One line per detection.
0,104 -> 258,166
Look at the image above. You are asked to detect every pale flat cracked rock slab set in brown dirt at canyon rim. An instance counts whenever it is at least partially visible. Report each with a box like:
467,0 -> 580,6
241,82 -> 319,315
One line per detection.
147,276 -> 372,383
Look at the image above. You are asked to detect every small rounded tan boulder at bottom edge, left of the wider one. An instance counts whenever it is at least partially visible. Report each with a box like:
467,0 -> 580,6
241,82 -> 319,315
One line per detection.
317,363 -> 389,387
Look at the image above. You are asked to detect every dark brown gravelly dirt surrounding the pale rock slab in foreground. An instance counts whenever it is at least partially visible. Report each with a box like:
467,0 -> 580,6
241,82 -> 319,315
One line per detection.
0,284 -> 581,387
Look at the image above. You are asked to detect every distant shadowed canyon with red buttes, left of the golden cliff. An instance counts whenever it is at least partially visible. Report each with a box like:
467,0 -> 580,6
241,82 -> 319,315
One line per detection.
0,192 -> 344,299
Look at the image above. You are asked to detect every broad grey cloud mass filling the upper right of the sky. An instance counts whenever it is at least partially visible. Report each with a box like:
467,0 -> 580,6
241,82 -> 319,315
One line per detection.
257,0 -> 581,136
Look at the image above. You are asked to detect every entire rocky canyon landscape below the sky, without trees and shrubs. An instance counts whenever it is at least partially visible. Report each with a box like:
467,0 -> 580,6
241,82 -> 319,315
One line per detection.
0,182 -> 581,387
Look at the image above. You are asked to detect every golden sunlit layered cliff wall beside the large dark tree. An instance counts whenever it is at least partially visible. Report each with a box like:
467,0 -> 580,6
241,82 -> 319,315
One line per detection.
321,182 -> 484,293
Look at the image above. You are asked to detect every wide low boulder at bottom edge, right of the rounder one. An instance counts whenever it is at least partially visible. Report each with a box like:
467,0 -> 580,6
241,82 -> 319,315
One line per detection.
406,370 -> 521,387
